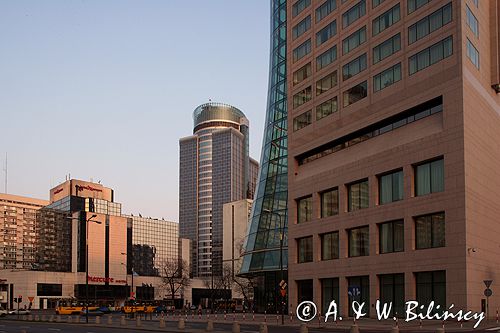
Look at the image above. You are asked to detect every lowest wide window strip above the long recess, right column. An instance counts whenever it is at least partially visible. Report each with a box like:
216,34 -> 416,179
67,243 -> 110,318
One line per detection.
408,36 -> 453,75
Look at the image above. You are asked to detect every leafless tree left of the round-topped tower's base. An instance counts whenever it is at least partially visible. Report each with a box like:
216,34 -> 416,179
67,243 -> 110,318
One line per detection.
160,258 -> 191,300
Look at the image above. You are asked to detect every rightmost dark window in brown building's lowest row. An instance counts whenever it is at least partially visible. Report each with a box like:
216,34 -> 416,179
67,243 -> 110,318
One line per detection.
415,271 -> 446,313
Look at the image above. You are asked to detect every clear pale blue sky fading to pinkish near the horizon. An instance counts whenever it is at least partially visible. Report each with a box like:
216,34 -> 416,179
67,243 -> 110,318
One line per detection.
0,0 -> 269,221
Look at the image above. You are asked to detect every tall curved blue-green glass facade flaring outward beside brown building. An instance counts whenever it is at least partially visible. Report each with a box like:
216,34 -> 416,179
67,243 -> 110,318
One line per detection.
240,0 -> 288,311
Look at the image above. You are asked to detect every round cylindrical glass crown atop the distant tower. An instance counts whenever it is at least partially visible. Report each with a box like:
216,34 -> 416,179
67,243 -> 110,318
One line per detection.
193,102 -> 248,132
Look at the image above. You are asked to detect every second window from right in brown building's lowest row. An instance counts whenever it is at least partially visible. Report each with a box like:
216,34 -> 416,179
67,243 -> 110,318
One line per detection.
378,273 -> 405,317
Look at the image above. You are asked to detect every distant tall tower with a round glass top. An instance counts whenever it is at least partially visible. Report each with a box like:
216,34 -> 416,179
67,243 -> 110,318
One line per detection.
179,102 -> 258,277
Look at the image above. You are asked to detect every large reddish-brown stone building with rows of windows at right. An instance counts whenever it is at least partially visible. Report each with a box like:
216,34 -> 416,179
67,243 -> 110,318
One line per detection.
287,0 -> 500,316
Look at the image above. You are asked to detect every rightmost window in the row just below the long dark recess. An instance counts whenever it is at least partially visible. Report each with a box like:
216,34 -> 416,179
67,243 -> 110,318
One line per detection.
415,158 -> 444,196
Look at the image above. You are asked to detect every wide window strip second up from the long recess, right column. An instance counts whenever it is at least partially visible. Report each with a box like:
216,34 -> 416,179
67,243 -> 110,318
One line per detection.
408,2 -> 452,44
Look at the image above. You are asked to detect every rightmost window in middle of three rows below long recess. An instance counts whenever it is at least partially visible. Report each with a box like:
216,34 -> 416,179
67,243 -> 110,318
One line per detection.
415,213 -> 445,249
